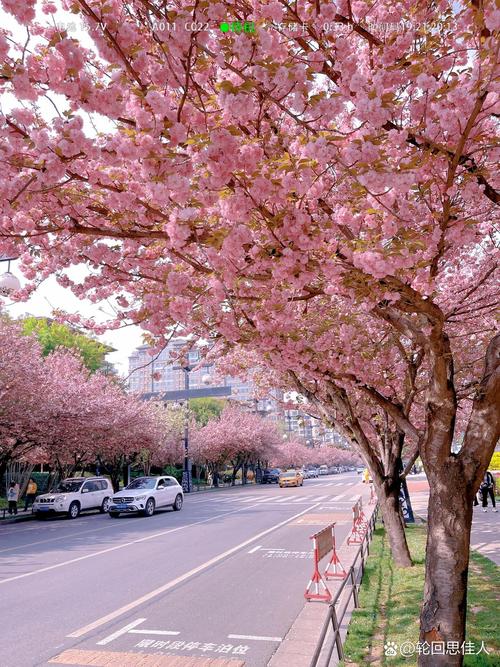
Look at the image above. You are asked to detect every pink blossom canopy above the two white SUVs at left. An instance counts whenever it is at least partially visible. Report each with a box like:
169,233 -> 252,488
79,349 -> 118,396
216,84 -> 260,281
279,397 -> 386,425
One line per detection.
0,320 -> 170,487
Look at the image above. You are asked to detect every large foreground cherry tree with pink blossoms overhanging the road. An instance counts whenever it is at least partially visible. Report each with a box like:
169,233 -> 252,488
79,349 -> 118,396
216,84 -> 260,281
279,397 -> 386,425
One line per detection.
0,0 -> 500,665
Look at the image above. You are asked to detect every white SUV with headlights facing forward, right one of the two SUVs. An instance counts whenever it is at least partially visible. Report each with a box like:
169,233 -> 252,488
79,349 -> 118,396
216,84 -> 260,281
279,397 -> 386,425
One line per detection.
109,476 -> 184,519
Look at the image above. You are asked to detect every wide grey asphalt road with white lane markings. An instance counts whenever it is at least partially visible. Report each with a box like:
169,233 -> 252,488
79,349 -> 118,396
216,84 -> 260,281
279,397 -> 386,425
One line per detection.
0,473 -> 363,667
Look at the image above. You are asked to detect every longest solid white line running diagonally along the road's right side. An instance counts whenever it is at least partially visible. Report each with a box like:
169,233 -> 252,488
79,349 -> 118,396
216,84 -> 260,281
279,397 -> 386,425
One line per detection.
66,504 -> 317,637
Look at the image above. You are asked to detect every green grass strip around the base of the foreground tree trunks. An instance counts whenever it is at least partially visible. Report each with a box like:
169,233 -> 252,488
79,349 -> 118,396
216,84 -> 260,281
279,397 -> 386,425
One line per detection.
341,526 -> 500,667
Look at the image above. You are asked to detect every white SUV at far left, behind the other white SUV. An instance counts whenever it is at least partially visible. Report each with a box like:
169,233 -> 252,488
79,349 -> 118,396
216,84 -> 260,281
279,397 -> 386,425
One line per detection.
33,477 -> 113,519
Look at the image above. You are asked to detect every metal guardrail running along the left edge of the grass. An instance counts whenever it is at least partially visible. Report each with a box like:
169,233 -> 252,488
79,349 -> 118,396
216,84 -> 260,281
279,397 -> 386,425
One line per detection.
310,504 -> 379,667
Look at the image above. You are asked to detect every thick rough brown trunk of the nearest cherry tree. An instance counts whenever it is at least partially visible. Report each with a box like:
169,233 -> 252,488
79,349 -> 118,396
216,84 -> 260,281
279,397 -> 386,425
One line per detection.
418,478 -> 474,667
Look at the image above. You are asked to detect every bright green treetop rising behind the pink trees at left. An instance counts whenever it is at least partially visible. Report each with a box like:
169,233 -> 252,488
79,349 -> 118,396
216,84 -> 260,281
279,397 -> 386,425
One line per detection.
22,317 -> 112,372
